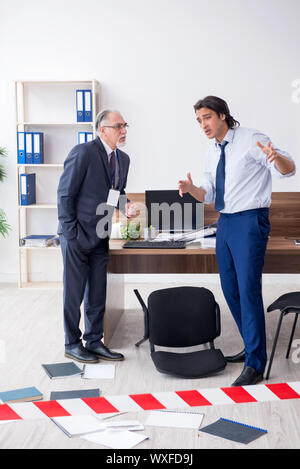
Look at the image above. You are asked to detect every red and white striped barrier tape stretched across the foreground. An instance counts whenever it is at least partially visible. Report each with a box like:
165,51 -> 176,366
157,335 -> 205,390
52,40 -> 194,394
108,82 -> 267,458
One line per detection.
0,381 -> 300,422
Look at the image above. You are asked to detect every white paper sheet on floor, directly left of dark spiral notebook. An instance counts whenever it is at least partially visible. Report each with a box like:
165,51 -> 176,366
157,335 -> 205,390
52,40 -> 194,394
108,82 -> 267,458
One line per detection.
145,410 -> 204,430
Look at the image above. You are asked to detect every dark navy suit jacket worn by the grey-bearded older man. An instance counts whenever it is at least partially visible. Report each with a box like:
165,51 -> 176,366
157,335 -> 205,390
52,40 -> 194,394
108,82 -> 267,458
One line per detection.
57,137 -> 129,249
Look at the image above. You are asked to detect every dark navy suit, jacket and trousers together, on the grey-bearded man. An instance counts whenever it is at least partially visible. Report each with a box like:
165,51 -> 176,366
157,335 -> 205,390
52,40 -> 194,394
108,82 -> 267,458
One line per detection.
57,137 -> 129,349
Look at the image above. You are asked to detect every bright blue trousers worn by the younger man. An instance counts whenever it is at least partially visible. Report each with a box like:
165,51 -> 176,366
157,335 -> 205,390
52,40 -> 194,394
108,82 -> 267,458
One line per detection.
216,208 -> 270,373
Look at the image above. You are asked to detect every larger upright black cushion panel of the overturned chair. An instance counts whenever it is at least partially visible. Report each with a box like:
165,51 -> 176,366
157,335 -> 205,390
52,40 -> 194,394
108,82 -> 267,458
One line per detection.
148,287 -> 221,347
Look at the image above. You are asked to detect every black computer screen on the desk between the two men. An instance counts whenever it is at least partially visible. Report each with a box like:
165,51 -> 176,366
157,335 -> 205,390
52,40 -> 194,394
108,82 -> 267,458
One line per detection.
145,190 -> 204,233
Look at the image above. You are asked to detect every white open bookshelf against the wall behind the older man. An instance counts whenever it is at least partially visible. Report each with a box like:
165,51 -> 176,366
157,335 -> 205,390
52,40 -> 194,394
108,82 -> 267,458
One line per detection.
15,80 -> 100,290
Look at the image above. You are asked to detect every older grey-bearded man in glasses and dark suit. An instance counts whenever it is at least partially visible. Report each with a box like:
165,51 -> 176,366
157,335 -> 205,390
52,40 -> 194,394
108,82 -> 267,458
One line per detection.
57,110 -> 136,363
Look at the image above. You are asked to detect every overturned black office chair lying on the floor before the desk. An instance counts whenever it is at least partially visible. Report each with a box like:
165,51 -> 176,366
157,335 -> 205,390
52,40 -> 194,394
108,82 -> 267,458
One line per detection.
134,287 -> 226,378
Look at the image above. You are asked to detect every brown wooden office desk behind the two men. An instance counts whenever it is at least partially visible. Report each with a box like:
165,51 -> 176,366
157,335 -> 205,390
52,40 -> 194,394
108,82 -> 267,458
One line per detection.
104,236 -> 300,343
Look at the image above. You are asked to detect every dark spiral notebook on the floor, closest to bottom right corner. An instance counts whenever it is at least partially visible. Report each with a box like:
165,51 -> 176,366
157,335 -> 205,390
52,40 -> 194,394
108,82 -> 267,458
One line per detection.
200,418 -> 267,444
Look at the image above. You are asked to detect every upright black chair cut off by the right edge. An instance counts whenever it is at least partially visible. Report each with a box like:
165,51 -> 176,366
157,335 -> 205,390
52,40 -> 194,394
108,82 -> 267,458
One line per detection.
266,291 -> 300,379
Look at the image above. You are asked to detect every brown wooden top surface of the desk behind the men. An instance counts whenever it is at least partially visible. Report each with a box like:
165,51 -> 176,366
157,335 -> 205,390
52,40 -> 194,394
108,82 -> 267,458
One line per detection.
109,236 -> 300,256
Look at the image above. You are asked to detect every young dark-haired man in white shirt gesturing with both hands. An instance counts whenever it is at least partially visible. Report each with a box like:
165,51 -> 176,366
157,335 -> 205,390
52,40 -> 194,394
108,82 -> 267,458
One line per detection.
178,96 -> 295,386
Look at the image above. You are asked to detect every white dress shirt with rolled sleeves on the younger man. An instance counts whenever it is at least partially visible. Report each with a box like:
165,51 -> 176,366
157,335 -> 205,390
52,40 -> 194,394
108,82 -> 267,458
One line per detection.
200,127 -> 296,213
